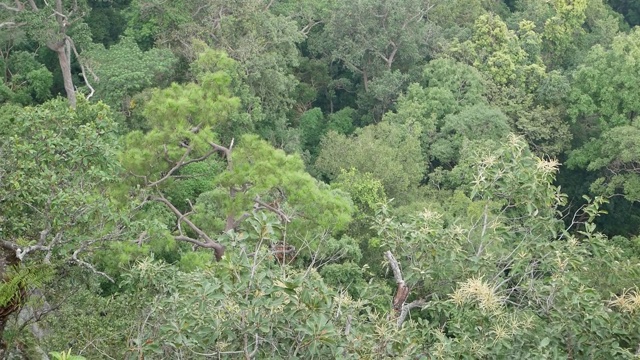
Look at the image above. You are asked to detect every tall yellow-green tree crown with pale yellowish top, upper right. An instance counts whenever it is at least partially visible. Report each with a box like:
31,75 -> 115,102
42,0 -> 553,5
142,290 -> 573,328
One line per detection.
449,15 -> 571,156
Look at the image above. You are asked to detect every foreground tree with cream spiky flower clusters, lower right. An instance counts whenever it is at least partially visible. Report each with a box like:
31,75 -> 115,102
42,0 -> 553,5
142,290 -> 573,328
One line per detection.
374,137 -> 639,358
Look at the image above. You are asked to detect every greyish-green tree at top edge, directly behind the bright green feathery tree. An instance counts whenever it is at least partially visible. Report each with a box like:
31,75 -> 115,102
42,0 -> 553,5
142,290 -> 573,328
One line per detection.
128,0 -> 304,129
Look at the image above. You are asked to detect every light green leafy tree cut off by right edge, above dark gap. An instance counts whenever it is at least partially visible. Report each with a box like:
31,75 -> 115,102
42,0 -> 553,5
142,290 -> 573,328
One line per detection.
568,30 -> 640,205
